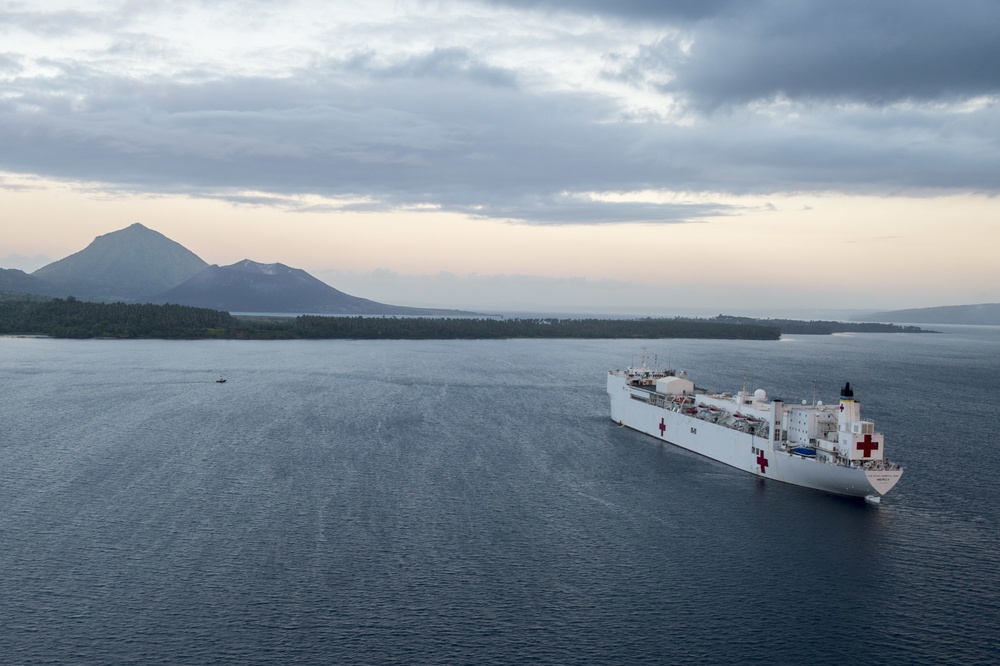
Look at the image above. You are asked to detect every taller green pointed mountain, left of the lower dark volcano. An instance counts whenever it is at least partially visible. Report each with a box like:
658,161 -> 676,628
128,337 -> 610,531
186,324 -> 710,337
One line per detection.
31,223 -> 208,301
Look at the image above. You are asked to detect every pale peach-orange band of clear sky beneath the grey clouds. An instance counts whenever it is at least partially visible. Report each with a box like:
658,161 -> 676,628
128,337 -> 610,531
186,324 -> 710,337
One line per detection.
0,177 -> 1000,312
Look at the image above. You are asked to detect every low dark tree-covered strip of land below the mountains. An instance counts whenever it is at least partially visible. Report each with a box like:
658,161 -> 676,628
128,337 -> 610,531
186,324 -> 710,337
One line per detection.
0,297 -> 921,340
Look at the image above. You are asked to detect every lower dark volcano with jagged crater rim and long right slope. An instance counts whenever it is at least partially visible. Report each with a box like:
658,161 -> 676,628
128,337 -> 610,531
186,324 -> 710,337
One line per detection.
151,259 -> 470,316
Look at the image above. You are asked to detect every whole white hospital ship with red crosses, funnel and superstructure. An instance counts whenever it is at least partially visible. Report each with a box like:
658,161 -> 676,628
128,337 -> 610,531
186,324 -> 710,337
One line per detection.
608,360 -> 903,503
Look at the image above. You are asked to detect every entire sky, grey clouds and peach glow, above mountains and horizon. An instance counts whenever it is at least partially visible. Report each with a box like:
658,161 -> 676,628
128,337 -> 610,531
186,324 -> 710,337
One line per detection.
0,0 -> 1000,316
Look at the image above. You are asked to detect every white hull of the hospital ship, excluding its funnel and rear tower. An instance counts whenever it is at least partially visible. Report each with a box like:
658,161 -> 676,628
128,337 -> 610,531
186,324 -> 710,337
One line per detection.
608,371 -> 903,502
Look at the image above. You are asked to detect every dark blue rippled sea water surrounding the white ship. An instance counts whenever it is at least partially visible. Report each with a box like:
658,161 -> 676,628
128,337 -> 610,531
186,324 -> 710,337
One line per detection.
0,328 -> 1000,664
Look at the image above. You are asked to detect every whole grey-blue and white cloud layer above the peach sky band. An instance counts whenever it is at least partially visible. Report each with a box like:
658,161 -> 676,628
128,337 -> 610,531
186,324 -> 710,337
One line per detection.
0,0 -> 1000,224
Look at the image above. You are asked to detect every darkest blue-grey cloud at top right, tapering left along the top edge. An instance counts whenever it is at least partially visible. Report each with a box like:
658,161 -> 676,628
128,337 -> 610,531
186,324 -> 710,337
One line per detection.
498,0 -> 1000,105
